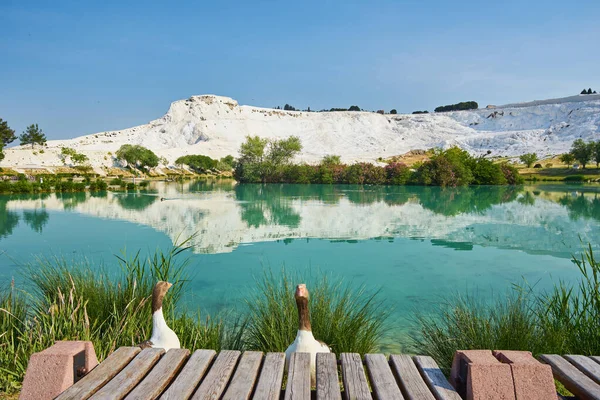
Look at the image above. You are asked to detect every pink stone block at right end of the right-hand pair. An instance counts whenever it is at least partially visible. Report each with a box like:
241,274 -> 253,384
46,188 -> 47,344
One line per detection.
494,350 -> 558,400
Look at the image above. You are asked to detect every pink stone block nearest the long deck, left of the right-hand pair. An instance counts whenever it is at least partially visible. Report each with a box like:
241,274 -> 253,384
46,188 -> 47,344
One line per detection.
450,350 -> 515,400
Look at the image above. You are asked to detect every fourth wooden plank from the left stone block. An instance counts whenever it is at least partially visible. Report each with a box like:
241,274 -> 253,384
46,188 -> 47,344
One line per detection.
161,350 -> 217,400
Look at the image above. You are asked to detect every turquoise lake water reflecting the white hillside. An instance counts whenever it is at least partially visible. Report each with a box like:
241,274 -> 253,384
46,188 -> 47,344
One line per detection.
0,181 -> 600,352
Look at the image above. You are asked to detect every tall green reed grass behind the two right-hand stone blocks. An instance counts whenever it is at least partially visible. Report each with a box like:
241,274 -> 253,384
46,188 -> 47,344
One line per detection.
412,245 -> 600,372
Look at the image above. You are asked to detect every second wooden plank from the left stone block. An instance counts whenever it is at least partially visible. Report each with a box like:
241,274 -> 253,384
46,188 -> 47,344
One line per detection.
91,348 -> 165,400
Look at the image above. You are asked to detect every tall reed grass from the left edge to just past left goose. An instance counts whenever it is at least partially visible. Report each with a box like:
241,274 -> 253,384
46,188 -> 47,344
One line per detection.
0,239 -> 241,393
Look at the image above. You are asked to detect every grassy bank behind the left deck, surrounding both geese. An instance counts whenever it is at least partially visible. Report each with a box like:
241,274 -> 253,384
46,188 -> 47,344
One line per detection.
0,238 -> 389,397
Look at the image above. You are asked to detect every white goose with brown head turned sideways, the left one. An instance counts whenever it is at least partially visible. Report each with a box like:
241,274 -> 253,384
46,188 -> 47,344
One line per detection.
139,281 -> 181,351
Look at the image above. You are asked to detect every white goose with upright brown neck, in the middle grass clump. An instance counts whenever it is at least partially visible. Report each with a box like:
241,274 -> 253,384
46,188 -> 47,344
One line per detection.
285,284 -> 331,385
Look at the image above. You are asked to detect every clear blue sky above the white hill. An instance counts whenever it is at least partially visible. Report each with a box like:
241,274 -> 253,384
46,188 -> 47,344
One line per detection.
0,0 -> 600,139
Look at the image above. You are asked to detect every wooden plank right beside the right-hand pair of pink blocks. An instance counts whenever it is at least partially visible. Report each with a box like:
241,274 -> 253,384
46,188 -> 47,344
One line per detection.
540,354 -> 600,400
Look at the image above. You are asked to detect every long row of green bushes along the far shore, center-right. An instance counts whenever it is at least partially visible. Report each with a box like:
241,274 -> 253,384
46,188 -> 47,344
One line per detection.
234,136 -> 523,187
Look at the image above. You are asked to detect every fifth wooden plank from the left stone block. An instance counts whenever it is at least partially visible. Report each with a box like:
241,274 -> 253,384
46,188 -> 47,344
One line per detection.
192,350 -> 241,400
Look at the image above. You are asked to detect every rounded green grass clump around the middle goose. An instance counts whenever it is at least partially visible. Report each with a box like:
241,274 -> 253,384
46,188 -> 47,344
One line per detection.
245,271 -> 389,354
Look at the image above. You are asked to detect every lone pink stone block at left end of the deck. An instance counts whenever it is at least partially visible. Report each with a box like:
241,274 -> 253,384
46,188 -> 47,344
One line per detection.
19,341 -> 98,400
